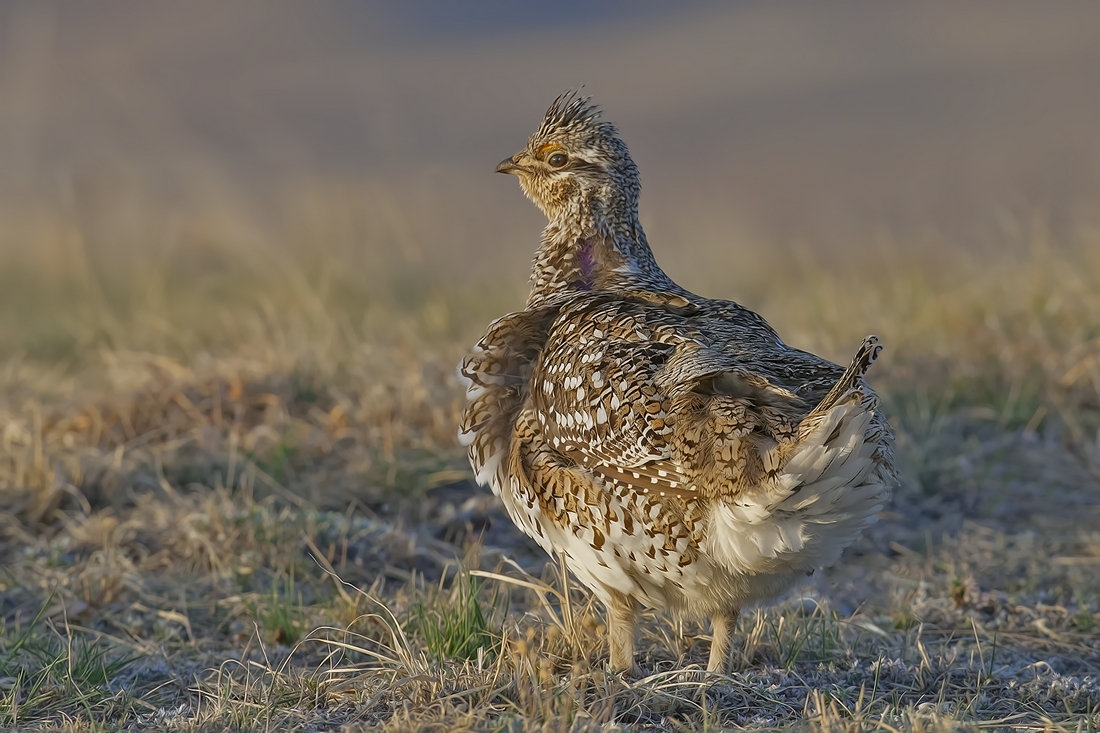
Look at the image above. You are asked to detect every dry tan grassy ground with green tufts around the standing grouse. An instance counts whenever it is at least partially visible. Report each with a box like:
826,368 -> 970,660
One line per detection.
0,214 -> 1100,731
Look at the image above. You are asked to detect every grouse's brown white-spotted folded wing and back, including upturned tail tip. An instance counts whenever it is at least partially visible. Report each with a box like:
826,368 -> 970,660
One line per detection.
519,294 -> 880,495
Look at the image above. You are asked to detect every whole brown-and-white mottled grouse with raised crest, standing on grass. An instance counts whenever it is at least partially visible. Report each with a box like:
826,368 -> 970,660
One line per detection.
459,94 -> 894,669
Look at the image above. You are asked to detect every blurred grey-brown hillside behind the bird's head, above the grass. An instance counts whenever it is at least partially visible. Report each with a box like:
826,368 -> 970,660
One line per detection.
0,0 -> 1100,288
